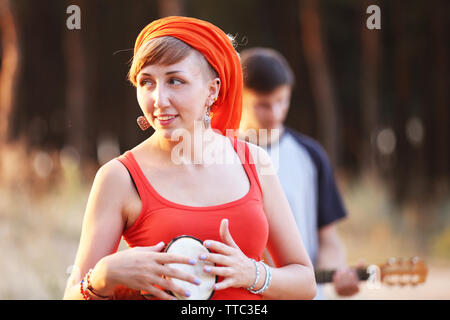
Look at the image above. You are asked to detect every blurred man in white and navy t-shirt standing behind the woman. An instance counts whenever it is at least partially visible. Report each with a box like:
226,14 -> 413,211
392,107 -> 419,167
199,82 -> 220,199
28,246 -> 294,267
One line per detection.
240,48 -> 359,299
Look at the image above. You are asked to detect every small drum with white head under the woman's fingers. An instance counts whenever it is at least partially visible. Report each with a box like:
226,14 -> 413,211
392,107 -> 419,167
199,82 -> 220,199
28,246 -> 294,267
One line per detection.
164,235 -> 217,300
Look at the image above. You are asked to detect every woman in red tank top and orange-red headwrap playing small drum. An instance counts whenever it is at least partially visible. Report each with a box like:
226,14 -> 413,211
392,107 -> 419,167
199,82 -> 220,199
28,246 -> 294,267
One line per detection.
64,17 -> 316,299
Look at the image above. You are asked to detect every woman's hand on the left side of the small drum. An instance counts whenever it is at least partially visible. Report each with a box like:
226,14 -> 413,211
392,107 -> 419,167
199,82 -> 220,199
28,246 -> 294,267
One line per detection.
91,242 -> 200,300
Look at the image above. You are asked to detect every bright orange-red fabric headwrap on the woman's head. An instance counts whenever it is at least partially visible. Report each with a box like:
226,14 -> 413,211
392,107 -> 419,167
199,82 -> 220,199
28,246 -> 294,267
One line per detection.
134,16 -> 243,135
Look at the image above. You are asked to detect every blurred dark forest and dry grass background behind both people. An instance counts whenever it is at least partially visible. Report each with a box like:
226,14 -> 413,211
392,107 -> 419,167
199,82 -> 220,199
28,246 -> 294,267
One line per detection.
0,0 -> 450,299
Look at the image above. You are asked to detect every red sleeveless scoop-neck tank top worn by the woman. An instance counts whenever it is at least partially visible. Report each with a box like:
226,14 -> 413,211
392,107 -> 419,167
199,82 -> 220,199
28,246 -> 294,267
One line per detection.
117,138 -> 269,300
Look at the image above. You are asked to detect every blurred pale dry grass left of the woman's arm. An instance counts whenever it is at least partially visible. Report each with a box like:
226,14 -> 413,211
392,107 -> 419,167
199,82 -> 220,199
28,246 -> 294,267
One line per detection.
0,142 -> 89,299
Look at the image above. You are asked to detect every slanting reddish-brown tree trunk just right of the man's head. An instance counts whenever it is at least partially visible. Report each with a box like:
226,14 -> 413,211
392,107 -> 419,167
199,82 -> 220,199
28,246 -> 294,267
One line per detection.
299,0 -> 339,165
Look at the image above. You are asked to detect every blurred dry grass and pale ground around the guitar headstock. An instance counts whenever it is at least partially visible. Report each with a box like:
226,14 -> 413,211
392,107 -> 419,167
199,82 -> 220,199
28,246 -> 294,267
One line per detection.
325,172 -> 450,300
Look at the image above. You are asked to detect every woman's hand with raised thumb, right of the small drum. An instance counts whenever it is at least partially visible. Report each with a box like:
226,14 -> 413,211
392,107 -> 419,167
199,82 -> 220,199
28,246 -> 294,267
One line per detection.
199,219 -> 256,290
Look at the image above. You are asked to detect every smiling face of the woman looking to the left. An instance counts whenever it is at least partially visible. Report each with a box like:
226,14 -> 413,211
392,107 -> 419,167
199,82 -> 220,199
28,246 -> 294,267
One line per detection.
137,52 -> 218,139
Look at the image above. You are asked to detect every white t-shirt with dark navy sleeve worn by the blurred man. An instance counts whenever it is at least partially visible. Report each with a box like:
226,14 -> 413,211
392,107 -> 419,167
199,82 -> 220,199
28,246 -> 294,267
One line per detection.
266,128 -> 346,299
